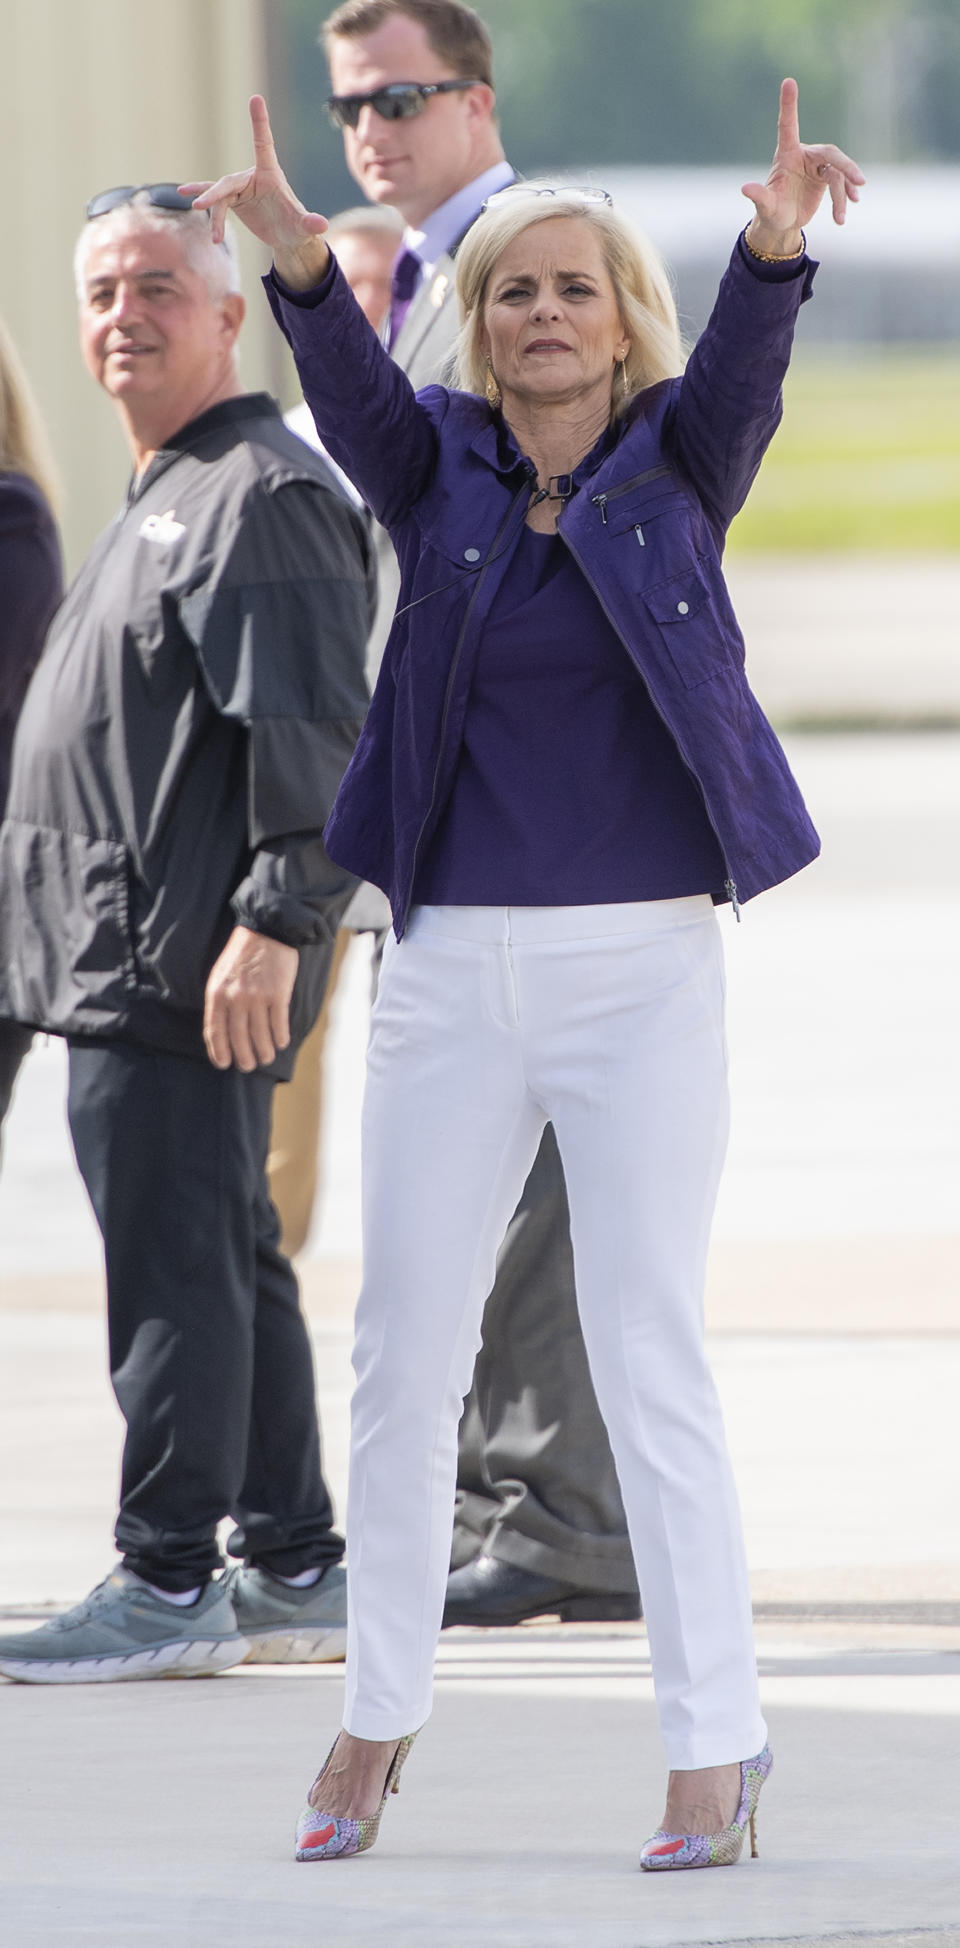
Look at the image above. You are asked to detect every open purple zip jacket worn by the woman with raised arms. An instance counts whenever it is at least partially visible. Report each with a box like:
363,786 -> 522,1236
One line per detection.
267,244 -> 820,939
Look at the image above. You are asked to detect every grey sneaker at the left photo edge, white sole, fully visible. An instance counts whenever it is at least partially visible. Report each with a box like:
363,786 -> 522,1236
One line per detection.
0,1566 -> 249,1685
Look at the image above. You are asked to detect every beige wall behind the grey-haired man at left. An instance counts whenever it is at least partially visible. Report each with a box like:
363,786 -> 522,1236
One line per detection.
0,0 -> 290,571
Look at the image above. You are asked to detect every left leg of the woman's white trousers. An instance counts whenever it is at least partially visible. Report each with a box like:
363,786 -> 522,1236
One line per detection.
345,921 -> 543,1738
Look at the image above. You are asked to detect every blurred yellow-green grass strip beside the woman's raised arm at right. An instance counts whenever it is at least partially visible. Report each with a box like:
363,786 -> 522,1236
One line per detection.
730,347 -> 960,555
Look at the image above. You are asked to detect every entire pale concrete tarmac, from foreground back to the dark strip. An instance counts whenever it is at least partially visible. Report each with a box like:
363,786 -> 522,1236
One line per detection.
0,734 -> 960,1948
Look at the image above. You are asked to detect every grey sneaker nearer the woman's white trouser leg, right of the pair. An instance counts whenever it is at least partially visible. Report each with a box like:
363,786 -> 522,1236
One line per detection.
220,1562 -> 347,1664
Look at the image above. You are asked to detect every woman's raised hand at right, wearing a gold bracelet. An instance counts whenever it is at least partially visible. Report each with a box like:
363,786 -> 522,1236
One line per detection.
742,80 -> 867,257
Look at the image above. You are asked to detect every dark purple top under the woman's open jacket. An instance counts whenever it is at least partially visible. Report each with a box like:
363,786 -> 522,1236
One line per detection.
413,528 -> 724,906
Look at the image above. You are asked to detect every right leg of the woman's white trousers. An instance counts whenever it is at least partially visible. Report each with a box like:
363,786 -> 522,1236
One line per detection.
528,912 -> 765,1769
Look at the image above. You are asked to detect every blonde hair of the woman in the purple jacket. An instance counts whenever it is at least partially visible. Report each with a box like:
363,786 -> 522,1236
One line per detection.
456,183 -> 683,419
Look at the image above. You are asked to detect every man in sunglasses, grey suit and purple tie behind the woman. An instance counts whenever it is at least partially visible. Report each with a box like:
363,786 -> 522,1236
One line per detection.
323,0 -> 639,1625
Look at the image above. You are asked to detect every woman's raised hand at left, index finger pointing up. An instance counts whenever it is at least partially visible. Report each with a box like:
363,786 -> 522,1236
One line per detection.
179,95 -> 329,290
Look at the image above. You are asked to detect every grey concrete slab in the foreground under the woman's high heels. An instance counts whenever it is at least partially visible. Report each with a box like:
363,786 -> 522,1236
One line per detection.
0,1627 -> 960,1948
